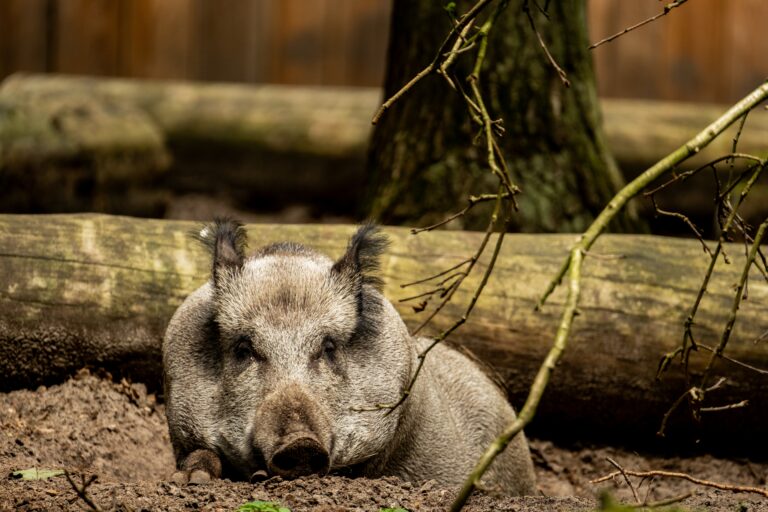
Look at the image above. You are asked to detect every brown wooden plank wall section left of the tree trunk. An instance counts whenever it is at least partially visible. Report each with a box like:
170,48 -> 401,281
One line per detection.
0,0 -> 390,86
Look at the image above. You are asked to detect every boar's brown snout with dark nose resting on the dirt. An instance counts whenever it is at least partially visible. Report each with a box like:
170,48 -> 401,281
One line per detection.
254,383 -> 333,478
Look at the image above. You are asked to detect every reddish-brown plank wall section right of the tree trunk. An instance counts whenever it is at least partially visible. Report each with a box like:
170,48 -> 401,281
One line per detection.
589,0 -> 768,103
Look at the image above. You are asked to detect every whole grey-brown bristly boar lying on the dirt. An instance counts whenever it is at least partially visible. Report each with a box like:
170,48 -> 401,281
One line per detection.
163,219 -> 535,494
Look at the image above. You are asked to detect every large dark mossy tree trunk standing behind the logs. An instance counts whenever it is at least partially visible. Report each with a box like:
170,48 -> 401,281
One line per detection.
368,0 -> 632,232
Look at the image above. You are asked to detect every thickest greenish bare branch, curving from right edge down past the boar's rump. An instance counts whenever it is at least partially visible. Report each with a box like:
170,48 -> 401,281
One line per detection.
451,83 -> 768,512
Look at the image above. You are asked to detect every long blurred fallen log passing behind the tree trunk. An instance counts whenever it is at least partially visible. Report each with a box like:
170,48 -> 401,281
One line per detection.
0,74 -> 768,222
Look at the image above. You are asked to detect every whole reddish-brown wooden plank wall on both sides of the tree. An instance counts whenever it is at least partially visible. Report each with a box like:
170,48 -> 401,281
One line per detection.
0,0 -> 768,102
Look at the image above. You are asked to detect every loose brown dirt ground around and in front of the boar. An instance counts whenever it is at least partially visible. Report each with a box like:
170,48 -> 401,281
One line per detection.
0,371 -> 768,512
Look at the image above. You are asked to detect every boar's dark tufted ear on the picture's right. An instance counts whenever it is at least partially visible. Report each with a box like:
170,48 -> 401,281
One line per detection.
331,224 -> 389,290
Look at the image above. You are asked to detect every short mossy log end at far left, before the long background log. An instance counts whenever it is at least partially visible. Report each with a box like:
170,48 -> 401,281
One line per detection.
0,79 -> 170,215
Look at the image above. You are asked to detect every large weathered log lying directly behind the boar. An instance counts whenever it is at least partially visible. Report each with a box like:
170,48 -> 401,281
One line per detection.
0,215 -> 768,456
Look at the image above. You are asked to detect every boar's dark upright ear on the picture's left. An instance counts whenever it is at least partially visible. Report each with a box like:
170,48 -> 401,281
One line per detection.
197,217 -> 247,286
